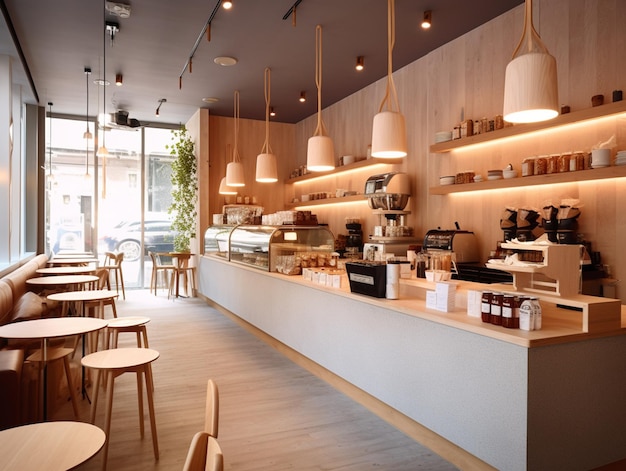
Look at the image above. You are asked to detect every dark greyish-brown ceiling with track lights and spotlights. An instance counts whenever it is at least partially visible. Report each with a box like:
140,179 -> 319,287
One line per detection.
0,0 -> 523,124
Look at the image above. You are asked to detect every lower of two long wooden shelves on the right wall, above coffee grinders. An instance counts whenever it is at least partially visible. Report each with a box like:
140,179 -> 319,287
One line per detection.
428,166 -> 626,195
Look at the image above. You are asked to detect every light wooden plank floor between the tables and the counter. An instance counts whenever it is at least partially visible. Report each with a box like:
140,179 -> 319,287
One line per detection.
52,290 -> 457,471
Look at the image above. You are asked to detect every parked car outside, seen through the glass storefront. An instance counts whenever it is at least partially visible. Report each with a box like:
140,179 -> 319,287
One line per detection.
100,219 -> 176,262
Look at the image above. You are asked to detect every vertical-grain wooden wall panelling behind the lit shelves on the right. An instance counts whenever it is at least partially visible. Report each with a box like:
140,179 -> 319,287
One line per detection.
296,0 -> 626,300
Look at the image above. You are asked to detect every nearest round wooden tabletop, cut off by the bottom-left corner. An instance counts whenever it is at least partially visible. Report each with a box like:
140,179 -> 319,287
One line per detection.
0,422 -> 106,471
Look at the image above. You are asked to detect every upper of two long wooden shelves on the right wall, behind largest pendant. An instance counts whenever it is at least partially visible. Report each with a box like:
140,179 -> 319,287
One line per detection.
430,101 -> 626,154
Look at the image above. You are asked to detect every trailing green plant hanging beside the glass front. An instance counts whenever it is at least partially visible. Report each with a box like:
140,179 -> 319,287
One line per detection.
165,126 -> 198,252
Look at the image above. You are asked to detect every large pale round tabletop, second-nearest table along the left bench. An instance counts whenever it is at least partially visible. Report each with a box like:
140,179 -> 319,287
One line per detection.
0,317 -> 107,342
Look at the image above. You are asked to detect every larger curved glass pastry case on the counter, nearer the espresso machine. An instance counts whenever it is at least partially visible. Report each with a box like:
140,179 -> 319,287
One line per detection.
224,225 -> 335,274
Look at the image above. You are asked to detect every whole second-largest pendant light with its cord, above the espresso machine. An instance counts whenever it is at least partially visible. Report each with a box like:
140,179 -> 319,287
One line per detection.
372,0 -> 407,159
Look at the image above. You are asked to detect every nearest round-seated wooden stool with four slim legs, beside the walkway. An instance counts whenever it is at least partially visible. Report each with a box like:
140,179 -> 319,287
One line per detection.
82,348 -> 159,470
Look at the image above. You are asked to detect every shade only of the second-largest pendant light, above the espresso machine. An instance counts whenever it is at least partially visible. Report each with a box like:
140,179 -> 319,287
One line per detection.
372,111 -> 407,159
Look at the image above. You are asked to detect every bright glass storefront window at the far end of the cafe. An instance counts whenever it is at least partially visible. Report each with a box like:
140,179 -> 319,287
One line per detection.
46,118 -> 173,288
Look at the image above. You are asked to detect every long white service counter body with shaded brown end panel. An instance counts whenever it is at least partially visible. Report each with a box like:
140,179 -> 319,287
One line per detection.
199,256 -> 626,470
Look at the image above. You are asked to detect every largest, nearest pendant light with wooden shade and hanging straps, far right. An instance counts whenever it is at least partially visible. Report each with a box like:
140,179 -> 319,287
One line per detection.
502,0 -> 559,123
